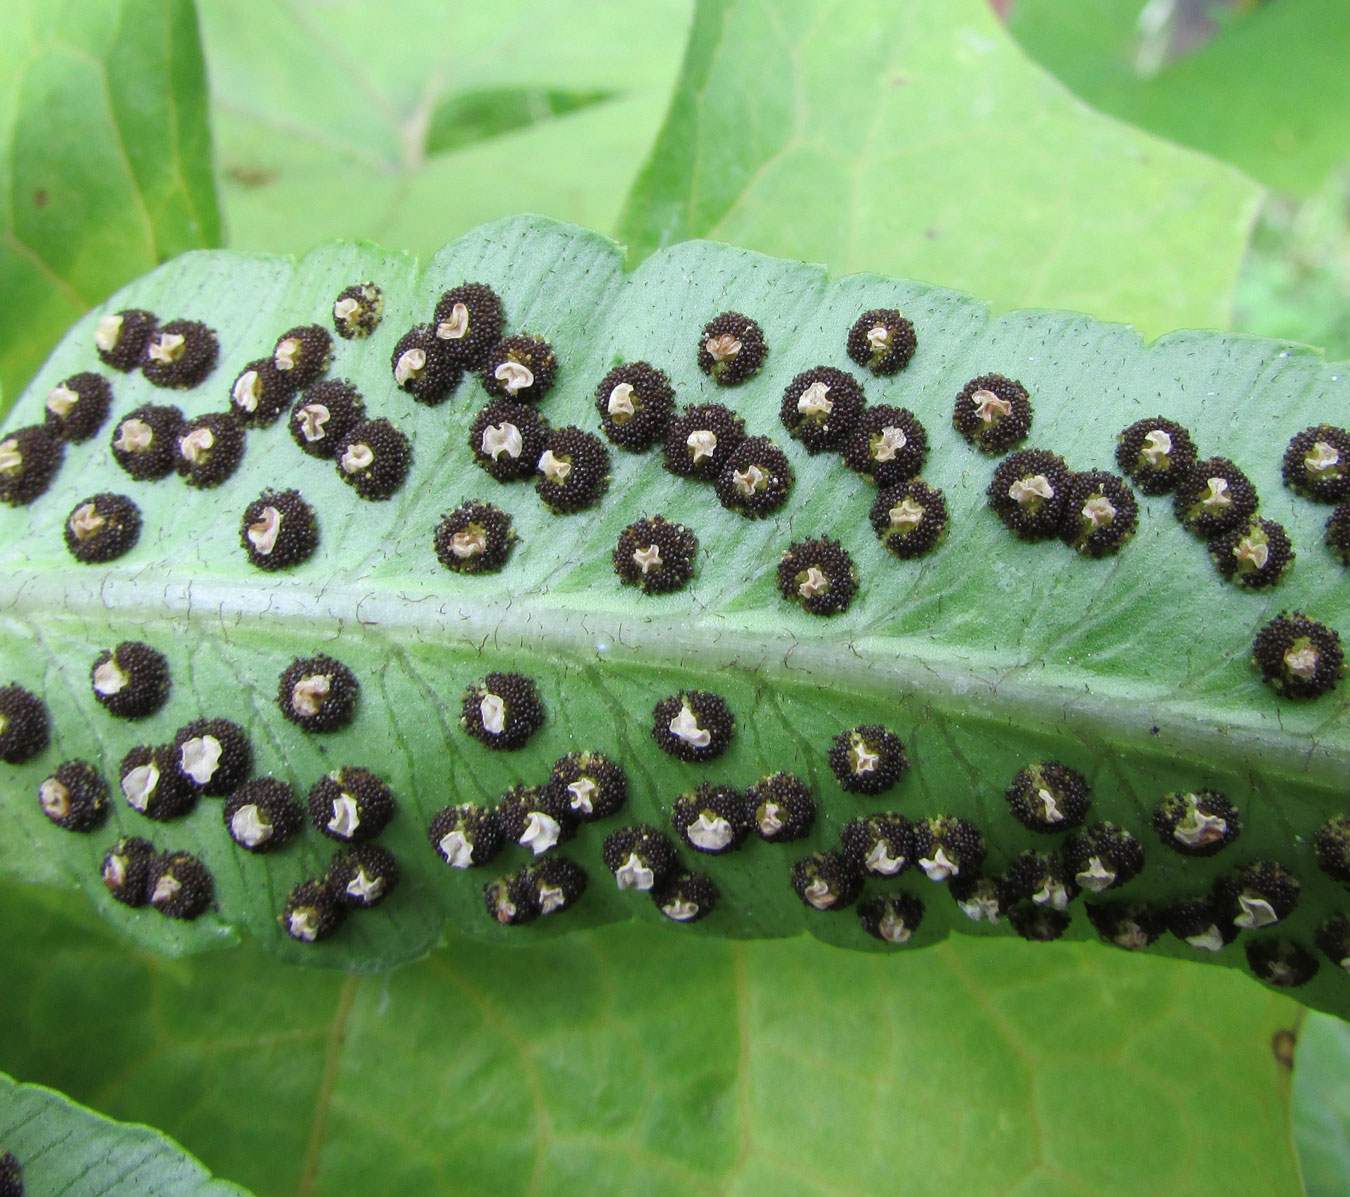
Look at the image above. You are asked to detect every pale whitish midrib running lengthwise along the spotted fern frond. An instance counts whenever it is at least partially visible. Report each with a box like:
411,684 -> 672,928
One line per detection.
0,571 -> 1350,794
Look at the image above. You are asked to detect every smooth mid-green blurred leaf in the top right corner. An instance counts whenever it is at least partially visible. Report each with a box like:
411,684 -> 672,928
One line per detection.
1010,0 -> 1350,196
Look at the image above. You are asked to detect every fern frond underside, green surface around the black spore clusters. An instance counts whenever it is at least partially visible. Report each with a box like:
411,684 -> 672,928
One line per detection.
0,217 -> 1350,1013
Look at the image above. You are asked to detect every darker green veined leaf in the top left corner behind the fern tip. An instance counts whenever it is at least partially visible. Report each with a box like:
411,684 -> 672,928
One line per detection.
0,0 -> 220,410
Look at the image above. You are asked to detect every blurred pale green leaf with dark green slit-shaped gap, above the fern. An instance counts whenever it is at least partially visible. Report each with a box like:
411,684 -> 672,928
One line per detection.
200,0 -> 689,256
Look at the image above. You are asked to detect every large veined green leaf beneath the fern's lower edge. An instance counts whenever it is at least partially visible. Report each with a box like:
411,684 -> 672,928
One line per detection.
0,884 -> 1297,1194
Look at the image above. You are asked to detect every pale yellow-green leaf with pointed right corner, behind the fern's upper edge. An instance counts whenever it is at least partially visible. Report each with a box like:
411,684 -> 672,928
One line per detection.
620,0 -> 1258,336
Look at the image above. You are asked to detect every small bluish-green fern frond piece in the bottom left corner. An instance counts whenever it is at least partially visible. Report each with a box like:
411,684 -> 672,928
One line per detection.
0,1073 -> 247,1197
